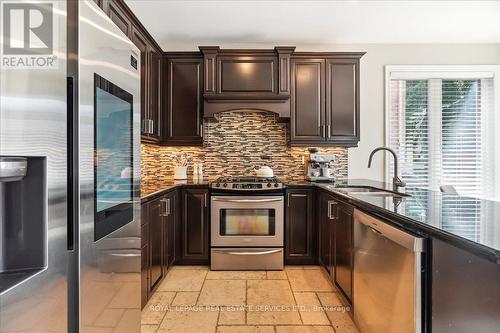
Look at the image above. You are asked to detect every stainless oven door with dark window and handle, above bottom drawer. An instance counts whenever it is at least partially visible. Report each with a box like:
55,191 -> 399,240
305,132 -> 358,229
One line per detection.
211,196 -> 284,247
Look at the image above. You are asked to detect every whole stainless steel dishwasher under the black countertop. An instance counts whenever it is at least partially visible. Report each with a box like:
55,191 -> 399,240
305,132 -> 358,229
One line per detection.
353,210 -> 424,333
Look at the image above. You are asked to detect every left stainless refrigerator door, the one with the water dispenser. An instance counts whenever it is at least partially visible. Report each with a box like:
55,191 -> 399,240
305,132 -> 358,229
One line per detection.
0,0 -> 69,333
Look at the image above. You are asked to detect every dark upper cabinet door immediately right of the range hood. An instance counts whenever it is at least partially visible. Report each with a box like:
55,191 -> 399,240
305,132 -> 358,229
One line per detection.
290,59 -> 325,143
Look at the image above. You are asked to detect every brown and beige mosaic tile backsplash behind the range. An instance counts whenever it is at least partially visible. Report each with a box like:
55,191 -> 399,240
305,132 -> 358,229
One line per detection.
141,111 -> 347,182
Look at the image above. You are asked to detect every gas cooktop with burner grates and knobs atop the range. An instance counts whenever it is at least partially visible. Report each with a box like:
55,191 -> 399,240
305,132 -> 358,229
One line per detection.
210,176 -> 284,191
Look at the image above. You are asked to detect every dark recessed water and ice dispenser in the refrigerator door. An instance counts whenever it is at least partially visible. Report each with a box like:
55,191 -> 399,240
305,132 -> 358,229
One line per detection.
0,156 -> 47,294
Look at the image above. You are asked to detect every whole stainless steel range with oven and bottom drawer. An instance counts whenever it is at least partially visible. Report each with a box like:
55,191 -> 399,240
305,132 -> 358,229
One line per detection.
210,177 -> 285,270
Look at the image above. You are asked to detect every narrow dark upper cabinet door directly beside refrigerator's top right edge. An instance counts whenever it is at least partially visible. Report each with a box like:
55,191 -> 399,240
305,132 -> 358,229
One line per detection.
131,27 -> 148,137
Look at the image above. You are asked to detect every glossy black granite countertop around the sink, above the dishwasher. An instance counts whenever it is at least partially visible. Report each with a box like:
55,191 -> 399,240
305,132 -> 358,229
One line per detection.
314,179 -> 500,264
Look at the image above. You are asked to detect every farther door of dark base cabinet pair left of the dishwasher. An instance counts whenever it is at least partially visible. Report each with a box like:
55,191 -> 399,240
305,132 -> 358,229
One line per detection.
317,192 -> 333,273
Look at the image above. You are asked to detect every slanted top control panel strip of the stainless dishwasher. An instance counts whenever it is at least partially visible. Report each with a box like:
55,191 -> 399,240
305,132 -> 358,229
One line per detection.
354,209 -> 425,252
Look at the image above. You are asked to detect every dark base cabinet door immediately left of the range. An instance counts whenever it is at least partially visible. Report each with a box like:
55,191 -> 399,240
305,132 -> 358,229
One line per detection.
182,189 -> 209,265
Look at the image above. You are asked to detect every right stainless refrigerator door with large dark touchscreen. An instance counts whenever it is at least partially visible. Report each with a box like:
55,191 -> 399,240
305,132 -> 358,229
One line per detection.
79,0 -> 141,332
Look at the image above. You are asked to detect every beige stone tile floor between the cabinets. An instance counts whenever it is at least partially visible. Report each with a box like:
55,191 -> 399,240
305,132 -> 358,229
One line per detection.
142,266 -> 359,333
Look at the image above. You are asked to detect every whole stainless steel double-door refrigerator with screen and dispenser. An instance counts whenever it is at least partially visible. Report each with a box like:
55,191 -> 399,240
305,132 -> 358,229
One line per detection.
0,0 -> 141,333
